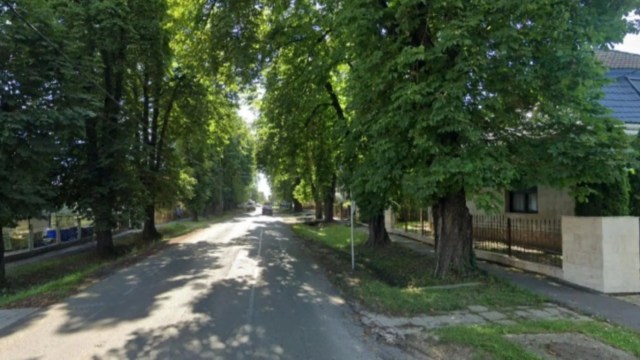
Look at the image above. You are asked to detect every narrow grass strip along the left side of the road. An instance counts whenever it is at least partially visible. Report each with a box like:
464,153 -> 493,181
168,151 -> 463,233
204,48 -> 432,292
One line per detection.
0,213 -> 235,308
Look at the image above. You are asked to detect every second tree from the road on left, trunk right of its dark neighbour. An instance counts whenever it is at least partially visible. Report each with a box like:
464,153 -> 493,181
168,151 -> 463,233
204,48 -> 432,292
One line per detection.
126,0 -> 184,240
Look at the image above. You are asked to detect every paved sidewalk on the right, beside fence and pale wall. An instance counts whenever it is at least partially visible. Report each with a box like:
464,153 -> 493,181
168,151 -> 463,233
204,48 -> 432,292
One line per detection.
390,235 -> 640,332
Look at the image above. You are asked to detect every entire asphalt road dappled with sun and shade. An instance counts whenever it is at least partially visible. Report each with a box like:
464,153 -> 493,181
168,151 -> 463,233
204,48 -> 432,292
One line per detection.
0,213 -> 398,359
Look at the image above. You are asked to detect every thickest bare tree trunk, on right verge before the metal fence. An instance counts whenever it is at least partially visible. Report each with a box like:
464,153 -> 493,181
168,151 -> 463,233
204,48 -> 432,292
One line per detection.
433,190 -> 476,278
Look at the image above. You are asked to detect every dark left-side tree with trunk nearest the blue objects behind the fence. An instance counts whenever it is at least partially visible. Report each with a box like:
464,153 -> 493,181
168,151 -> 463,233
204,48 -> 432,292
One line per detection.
77,0 -> 135,256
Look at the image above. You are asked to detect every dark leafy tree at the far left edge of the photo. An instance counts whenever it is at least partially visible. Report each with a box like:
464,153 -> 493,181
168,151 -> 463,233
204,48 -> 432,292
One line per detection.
0,1 -> 90,285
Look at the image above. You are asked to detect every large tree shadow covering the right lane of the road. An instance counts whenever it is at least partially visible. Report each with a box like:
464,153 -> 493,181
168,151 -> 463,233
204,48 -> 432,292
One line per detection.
93,221 -> 368,359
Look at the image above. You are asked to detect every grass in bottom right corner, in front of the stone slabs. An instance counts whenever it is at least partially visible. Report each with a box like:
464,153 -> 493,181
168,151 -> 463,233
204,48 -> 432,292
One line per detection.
434,320 -> 640,359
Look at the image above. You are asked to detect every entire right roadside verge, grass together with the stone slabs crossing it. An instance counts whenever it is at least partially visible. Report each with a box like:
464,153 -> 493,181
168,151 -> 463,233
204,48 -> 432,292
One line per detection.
293,224 -> 640,360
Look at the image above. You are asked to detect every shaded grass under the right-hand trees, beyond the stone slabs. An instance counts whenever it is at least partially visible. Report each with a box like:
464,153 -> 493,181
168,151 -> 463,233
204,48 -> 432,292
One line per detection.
293,224 -> 545,315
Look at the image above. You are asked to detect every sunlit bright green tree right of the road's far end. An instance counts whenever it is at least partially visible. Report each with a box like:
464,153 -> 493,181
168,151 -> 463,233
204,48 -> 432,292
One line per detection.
258,1 -> 346,221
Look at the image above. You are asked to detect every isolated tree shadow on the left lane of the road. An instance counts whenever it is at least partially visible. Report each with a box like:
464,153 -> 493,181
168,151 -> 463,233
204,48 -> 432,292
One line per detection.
58,241 -> 228,333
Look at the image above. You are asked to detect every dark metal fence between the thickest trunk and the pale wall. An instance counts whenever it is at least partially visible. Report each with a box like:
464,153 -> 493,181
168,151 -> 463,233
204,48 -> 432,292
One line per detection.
473,215 -> 562,267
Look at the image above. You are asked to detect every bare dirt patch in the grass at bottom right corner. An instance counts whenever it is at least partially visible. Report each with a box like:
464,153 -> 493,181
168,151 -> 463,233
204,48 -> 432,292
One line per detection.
507,333 -> 636,360
